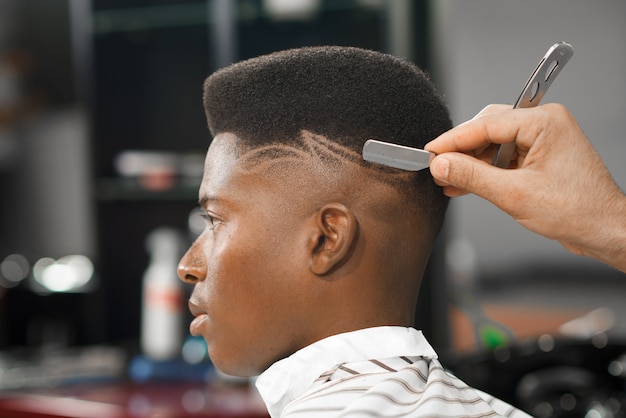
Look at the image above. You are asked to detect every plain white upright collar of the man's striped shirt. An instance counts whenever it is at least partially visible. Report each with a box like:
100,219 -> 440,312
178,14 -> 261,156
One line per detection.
256,327 -> 437,417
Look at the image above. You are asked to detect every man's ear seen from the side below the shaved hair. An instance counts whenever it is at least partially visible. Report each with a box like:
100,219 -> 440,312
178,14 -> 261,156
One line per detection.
309,203 -> 358,276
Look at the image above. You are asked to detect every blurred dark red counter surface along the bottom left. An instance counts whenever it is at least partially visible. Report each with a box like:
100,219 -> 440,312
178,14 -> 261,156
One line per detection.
0,382 -> 269,418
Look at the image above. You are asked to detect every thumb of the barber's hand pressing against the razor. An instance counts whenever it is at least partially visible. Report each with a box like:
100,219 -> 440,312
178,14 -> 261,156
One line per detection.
430,152 -> 509,204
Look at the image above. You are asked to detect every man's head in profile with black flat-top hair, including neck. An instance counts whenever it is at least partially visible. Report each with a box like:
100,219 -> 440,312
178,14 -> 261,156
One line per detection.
179,47 -> 451,375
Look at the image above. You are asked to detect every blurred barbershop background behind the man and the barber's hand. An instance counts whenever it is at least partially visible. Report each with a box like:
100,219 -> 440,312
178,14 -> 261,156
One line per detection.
0,0 -> 626,418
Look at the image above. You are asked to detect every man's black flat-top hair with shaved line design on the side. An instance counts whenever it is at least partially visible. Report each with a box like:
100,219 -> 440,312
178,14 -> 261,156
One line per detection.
204,46 -> 452,234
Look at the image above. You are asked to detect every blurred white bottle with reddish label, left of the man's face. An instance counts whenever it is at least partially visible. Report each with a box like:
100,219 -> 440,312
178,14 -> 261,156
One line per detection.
141,228 -> 184,360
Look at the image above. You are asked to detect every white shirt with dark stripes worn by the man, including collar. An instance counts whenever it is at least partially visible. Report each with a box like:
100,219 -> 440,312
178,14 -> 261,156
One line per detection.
257,327 -> 528,418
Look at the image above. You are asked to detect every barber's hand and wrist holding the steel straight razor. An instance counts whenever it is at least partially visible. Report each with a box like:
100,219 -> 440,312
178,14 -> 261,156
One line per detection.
425,104 -> 626,272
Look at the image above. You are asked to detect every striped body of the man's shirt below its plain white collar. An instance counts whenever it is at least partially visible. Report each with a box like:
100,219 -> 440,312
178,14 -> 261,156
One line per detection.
282,358 -> 528,418
